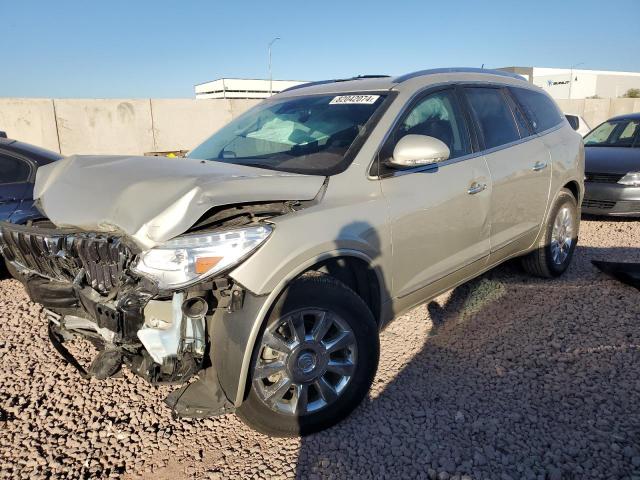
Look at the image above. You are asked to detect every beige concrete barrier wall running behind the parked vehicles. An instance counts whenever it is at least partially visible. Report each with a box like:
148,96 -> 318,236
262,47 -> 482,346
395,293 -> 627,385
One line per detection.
0,98 -> 640,155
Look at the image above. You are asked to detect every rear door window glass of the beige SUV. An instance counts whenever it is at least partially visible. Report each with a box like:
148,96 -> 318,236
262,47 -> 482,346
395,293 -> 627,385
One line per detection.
464,87 -> 520,149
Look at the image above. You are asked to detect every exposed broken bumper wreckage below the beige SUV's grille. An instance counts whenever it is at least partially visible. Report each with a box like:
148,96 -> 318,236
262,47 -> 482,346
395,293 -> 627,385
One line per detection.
12,262 -> 209,384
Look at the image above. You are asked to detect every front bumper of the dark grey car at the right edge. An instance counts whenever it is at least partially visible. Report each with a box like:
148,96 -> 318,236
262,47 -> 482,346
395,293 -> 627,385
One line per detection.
582,182 -> 640,217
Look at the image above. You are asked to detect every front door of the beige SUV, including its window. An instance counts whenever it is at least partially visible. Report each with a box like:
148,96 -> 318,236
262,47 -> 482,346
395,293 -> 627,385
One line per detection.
380,89 -> 491,297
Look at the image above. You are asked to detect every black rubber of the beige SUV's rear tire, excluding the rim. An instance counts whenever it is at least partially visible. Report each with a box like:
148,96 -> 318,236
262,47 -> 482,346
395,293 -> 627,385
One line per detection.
522,188 -> 580,278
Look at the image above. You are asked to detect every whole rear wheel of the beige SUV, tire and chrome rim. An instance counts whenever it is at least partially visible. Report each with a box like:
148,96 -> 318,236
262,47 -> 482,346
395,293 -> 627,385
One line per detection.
522,188 -> 580,278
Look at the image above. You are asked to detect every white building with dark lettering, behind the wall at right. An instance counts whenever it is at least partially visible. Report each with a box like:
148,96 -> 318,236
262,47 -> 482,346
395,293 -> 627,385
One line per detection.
498,67 -> 640,99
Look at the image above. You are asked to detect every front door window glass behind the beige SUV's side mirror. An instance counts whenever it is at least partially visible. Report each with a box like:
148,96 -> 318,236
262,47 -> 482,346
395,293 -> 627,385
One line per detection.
389,90 -> 471,162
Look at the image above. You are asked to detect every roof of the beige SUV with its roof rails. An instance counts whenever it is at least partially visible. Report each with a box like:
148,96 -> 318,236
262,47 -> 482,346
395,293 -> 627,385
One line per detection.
274,67 -> 529,98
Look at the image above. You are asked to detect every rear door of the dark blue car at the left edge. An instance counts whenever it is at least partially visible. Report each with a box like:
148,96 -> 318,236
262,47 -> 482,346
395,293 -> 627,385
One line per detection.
0,151 -> 33,221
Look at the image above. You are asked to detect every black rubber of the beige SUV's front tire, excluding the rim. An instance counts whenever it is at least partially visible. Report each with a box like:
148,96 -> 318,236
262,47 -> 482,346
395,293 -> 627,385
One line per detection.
236,273 -> 380,437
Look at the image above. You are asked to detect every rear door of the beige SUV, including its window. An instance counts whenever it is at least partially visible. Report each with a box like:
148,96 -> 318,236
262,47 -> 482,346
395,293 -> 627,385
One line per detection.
464,86 -> 552,255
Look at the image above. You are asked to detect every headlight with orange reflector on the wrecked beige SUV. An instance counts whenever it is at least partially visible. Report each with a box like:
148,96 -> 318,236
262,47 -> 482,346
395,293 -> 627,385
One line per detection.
133,225 -> 272,290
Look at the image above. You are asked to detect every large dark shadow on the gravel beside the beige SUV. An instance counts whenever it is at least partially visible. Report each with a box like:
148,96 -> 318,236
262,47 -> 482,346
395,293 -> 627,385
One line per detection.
296,247 -> 640,480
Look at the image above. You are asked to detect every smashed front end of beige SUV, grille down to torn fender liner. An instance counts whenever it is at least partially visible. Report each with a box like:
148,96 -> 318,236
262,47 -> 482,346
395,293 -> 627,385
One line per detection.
0,223 -> 264,416
